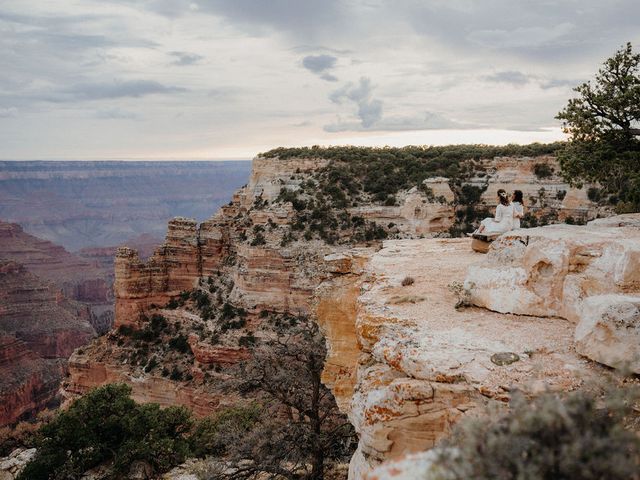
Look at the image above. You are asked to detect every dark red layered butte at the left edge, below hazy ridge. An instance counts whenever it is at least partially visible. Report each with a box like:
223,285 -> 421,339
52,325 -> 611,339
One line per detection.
0,260 -> 95,425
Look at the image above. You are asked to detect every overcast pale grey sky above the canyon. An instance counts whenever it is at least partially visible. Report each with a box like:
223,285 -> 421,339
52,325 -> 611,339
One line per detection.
0,0 -> 640,160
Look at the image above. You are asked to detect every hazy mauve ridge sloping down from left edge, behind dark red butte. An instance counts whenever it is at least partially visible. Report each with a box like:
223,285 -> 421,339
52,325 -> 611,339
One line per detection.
0,222 -> 111,303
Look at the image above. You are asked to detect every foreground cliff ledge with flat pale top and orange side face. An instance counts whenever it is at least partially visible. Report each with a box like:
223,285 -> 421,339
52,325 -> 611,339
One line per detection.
316,239 -> 599,479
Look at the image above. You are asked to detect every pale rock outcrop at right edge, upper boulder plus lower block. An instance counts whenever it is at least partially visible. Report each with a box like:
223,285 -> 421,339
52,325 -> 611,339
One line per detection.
465,215 -> 640,373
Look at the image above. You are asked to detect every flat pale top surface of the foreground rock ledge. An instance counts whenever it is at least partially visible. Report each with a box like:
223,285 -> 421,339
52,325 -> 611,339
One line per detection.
359,239 -> 589,391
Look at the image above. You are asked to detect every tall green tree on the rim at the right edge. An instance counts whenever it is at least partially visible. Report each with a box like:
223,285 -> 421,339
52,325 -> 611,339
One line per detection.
556,43 -> 640,213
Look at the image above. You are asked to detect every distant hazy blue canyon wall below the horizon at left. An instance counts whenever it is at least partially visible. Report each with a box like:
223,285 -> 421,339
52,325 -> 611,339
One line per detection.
0,161 -> 251,252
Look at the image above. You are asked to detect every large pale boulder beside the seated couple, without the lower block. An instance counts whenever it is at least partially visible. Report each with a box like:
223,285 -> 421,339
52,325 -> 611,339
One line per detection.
465,220 -> 640,323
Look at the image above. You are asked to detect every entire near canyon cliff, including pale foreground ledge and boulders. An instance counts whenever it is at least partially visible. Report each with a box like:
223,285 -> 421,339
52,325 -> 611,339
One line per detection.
5,148 -> 638,479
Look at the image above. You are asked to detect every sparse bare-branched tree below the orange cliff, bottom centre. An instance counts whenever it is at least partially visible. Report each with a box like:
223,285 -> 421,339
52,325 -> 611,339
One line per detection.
199,317 -> 354,480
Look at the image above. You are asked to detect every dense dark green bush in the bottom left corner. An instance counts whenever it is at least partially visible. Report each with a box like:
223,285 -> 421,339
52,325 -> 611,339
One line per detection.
18,384 -> 192,480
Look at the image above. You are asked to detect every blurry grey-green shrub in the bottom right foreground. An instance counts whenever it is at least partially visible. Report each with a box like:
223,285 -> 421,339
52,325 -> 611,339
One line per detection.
439,392 -> 640,480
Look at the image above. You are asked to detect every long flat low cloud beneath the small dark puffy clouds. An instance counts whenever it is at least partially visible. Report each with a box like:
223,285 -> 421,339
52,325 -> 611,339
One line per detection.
324,111 -> 470,133
